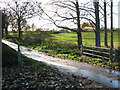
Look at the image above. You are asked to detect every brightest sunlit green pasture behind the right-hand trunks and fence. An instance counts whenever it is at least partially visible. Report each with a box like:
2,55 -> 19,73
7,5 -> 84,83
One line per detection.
47,31 -> 120,48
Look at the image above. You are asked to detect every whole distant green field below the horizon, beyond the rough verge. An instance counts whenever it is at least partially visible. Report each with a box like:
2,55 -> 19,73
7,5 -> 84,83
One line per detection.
10,31 -> 120,49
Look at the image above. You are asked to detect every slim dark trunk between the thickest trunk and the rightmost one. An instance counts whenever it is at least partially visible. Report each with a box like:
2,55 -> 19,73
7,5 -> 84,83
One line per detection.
104,0 -> 108,47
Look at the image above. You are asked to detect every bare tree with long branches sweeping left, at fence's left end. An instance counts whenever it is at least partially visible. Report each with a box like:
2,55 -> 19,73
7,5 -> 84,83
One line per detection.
38,0 -> 98,49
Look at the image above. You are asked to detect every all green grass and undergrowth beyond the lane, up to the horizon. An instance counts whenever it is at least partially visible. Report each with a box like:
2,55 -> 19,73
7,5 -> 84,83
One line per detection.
3,31 -> 120,71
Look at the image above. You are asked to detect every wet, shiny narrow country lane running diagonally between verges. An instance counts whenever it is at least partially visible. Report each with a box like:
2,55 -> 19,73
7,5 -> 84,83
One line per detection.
2,40 -> 120,88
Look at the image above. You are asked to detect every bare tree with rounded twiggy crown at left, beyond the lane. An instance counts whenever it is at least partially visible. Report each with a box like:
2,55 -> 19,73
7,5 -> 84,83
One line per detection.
7,0 -> 35,39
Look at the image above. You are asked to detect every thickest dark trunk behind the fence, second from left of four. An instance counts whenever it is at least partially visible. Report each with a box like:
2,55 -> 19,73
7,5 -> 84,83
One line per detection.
94,1 -> 100,47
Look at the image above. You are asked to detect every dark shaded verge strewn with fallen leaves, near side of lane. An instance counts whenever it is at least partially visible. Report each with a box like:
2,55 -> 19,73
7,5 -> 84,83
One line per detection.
2,44 -> 104,90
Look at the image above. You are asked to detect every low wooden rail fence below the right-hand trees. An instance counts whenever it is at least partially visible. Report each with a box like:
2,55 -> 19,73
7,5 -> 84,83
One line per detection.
81,45 -> 115,60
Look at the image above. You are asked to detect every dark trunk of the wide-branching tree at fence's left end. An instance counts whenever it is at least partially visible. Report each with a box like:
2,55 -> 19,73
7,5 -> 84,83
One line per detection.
76,0 -> 82,49
